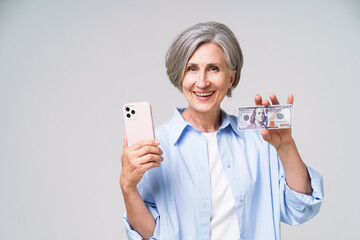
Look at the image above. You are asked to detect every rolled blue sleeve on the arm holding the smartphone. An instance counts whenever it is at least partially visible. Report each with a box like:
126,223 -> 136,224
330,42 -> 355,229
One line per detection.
123,204 -> 160,240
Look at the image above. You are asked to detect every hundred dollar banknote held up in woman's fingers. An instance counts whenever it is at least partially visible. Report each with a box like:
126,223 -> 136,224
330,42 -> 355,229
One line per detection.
238,104 -> 292,130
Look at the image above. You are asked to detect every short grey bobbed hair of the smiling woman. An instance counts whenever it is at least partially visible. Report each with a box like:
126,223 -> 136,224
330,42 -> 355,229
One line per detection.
165,22 -> 244,97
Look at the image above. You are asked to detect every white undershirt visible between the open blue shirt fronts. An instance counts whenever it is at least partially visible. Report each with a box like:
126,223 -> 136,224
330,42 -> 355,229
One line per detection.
203,132 -> 240,240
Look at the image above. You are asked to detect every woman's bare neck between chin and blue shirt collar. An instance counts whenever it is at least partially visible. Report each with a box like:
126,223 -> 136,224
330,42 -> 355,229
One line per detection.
181,106 -> 221,132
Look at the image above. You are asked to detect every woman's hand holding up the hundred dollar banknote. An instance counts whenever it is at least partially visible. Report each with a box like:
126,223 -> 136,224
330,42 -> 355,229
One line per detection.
255,94 -> 294,151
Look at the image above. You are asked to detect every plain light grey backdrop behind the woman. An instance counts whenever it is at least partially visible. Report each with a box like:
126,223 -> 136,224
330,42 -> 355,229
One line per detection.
0,0 -> 360,240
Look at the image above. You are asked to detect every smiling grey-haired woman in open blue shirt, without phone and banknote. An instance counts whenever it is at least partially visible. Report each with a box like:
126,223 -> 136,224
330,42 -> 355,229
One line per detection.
120,22 -> 323,240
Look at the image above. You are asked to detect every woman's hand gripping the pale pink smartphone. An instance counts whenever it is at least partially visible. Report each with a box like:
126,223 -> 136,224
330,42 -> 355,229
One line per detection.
120,136 -> 163,192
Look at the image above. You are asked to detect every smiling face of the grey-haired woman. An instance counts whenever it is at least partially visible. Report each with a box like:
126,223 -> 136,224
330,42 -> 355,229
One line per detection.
182,43 -> 236,113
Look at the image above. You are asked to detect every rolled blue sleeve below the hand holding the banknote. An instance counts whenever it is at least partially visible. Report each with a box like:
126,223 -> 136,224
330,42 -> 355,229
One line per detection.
280,167 -> 324,225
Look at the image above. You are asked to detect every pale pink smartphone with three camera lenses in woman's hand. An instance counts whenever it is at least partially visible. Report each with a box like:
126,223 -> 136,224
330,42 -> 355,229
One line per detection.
123,102 -> 155,146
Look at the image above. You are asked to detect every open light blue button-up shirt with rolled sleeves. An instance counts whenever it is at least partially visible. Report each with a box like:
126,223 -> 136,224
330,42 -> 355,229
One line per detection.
124,109 -> 323,240
